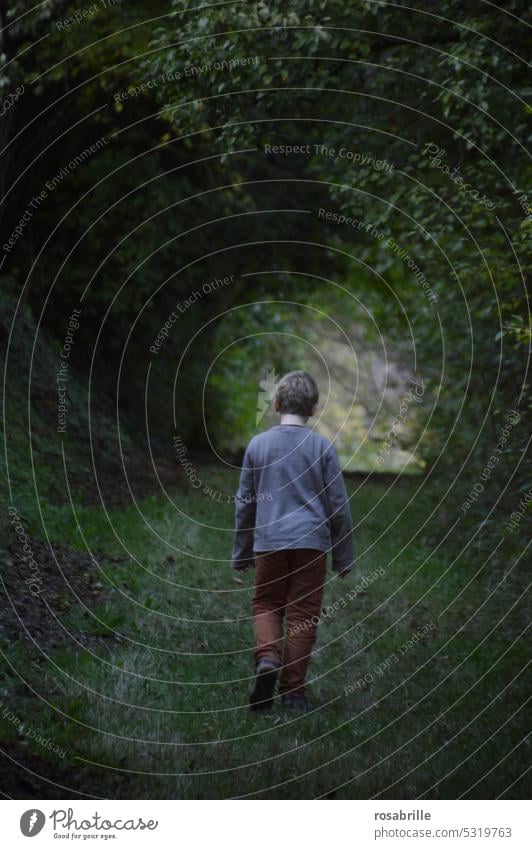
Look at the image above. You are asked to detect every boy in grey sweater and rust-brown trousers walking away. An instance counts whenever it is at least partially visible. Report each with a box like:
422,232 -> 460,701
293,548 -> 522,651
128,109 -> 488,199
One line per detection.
232,371 -> 353,711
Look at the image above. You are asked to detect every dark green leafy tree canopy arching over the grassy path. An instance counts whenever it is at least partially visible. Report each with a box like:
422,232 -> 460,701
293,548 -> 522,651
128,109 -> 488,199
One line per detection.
1,0 -> 532,476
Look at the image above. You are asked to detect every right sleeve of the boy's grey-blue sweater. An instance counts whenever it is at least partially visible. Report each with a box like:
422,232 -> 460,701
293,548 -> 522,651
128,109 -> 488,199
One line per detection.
324,444 -> 354,572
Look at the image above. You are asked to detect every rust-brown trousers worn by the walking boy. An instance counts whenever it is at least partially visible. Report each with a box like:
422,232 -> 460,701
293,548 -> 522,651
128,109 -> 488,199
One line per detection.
253,548 -> 327,696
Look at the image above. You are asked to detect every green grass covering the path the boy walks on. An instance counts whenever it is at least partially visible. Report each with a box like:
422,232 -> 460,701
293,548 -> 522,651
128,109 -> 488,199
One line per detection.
0,466 -> 526,799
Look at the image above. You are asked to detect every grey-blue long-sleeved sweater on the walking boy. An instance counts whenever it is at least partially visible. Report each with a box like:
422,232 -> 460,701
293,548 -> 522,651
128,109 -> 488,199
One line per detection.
232,424 -> 353,572
